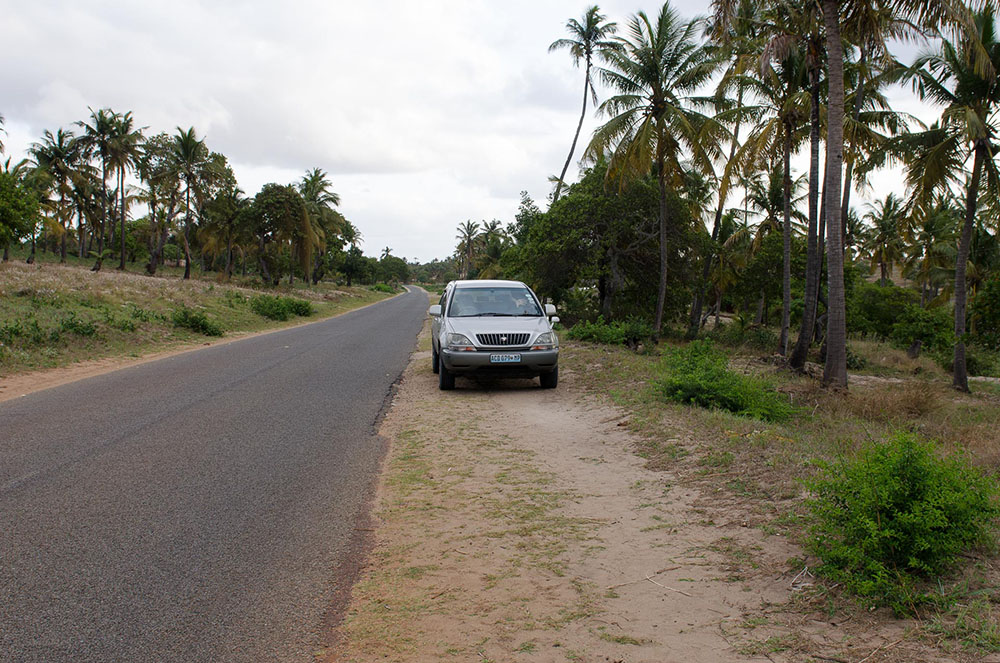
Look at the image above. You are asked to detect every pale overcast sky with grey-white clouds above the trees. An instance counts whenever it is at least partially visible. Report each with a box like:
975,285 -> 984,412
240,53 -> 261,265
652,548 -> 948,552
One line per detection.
0,0 -> 933,262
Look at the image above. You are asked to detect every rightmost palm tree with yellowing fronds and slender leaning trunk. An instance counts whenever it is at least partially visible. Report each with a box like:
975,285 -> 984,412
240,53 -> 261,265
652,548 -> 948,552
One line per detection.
907,7 -> 1000,392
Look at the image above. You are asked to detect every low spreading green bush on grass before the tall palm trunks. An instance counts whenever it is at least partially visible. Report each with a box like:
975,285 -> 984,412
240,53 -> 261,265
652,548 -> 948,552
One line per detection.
654,341 -> 793,421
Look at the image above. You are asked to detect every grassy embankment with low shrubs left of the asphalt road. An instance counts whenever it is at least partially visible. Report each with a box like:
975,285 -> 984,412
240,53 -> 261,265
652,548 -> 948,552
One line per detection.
0,254 -> 391,377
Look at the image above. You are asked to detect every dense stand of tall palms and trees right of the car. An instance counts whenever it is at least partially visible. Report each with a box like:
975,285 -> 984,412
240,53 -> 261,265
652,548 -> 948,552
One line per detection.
432,0 -> 1000,390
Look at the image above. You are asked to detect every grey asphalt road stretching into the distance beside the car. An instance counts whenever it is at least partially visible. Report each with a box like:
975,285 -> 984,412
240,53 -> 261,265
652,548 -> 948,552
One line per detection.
0,290 -> 427,663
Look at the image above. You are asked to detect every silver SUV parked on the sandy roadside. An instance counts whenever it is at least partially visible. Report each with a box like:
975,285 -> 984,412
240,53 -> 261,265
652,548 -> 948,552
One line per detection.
428,281 -> 559,389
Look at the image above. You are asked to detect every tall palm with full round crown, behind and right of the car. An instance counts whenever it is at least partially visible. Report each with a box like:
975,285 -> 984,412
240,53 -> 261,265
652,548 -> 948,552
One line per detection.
587,2 -> 725,335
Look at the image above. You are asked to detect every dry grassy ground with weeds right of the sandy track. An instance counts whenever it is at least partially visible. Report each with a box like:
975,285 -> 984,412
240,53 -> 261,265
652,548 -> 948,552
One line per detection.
561,330 -> 1000,652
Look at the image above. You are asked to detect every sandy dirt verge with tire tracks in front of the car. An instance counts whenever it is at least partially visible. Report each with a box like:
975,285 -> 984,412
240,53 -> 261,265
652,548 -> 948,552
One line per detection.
328,320 -> 1000,663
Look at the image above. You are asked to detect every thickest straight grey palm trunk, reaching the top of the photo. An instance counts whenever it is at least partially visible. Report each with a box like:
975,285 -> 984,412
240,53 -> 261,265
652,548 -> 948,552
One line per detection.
823,0 -> 847,389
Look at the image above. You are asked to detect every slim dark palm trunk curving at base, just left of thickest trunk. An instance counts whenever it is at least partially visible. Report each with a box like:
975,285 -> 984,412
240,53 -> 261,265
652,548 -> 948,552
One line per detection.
789,67 -> 821,370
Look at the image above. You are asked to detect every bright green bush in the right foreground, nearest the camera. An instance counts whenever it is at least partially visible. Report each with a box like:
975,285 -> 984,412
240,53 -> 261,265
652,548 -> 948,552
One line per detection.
806,433 -> 1000,612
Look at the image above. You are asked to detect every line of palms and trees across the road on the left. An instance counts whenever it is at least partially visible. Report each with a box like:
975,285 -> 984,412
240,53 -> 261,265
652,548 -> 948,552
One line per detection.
0,108 -> 408,285
